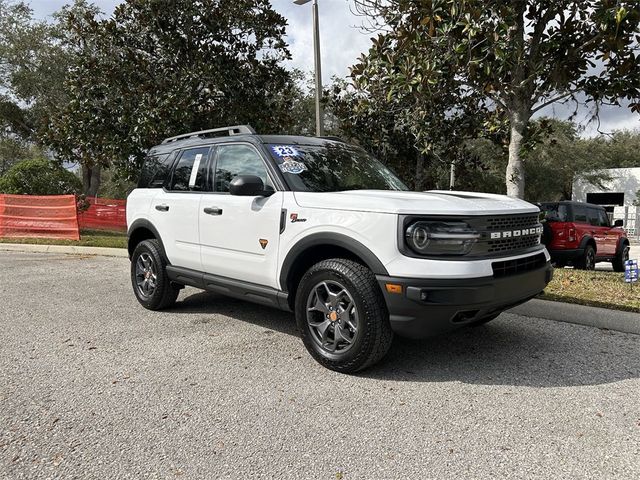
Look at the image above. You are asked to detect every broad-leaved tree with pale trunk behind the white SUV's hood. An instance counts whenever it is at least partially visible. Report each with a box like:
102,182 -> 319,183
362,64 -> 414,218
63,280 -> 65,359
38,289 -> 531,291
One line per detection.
353,0 -> 640,197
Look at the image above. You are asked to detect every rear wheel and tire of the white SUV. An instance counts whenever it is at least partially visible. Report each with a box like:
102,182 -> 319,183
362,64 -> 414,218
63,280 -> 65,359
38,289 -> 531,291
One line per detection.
131,239 -> 180,310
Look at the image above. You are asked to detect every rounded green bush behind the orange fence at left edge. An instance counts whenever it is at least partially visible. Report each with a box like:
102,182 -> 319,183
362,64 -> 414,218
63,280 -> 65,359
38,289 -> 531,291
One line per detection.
0,159 -> 82,195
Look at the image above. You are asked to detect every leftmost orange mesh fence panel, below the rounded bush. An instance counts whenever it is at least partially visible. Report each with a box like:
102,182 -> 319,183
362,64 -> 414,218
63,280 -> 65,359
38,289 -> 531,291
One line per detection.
0,194 -> 80,240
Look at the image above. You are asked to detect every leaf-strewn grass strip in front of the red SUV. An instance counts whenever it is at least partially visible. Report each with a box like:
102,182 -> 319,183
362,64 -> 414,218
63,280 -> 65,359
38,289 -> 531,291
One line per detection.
539,268 -> 640,313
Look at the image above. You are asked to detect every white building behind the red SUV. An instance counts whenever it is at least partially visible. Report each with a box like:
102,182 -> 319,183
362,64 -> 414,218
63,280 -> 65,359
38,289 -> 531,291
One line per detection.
572,168 -> 640,240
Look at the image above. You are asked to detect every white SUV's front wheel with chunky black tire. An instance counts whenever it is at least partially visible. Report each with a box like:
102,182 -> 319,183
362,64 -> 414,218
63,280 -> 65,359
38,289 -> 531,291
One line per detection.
295,258 -> 393,373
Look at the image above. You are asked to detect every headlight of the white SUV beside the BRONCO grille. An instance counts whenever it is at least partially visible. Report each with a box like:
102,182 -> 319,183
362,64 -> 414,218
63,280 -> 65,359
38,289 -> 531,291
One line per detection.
405,221 -> 480,255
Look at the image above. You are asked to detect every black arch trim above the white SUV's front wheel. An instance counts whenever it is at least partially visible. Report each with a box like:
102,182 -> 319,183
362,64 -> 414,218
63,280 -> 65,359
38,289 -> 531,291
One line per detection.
280,232 -> 389,292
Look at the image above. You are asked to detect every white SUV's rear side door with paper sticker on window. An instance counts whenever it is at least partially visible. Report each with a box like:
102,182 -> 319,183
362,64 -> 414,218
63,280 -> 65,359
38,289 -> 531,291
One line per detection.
150,147 -> 210,270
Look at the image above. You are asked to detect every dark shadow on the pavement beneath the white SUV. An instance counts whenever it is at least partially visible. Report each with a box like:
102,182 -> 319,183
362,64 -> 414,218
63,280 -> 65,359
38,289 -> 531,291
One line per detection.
169,292 -> 640,387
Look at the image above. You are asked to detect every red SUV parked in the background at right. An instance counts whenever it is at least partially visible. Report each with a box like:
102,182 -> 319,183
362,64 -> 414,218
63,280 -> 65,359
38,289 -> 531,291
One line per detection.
540,202 -> 629,272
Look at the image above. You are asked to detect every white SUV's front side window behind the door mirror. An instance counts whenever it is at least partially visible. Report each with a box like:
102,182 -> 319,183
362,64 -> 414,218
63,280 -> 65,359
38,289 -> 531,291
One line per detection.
213,144 -> 273,193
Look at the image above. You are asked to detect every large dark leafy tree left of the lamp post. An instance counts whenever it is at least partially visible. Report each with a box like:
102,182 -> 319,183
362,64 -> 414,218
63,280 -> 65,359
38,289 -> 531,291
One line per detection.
48,0 -> 293,184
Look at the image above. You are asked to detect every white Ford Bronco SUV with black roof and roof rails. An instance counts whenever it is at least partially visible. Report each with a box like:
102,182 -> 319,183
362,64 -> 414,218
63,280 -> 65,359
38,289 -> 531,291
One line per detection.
127,126 -> 553,372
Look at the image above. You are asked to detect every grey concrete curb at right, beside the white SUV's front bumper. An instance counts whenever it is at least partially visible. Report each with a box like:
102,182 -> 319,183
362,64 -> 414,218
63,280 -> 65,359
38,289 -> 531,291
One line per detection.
508,299 -> 640,335
